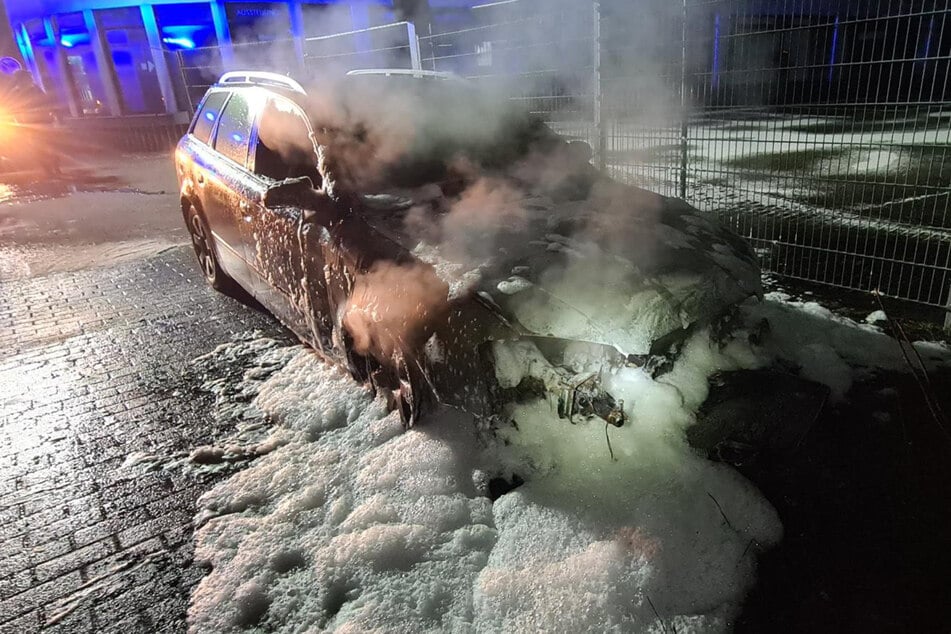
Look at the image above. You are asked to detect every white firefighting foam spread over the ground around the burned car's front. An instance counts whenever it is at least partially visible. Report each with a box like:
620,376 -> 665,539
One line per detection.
189,297 -> 947,632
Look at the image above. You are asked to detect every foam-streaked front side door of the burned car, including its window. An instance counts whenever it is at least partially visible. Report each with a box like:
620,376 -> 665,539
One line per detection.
243,96 -> 333,349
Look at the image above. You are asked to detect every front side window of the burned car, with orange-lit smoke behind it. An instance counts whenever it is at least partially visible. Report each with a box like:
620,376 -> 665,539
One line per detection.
254,99 -> 321,189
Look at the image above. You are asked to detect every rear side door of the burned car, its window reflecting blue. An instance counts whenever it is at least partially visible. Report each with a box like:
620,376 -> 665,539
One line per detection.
205,91 -> 263,278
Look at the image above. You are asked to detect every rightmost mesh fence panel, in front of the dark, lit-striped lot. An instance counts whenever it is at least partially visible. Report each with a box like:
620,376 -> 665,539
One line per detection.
685,0 -> 951,306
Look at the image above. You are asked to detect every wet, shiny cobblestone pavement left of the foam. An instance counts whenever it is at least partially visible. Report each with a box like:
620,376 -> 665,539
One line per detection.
0,247 -> 285,633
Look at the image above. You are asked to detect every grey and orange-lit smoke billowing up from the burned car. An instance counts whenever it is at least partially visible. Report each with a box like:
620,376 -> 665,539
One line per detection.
212,0 -> 712,356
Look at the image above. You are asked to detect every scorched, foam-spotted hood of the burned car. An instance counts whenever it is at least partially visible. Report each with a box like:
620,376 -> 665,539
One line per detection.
360,179 -> 761,355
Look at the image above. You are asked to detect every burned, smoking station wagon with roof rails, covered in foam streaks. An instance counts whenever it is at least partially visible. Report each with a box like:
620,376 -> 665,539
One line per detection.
175,70 -> 761,426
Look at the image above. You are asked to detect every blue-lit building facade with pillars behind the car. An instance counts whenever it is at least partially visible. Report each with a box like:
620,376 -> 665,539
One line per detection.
6,0 -> 469,117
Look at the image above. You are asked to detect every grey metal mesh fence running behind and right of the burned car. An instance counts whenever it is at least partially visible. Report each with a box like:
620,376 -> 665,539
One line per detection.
420,0 -> 951,306
